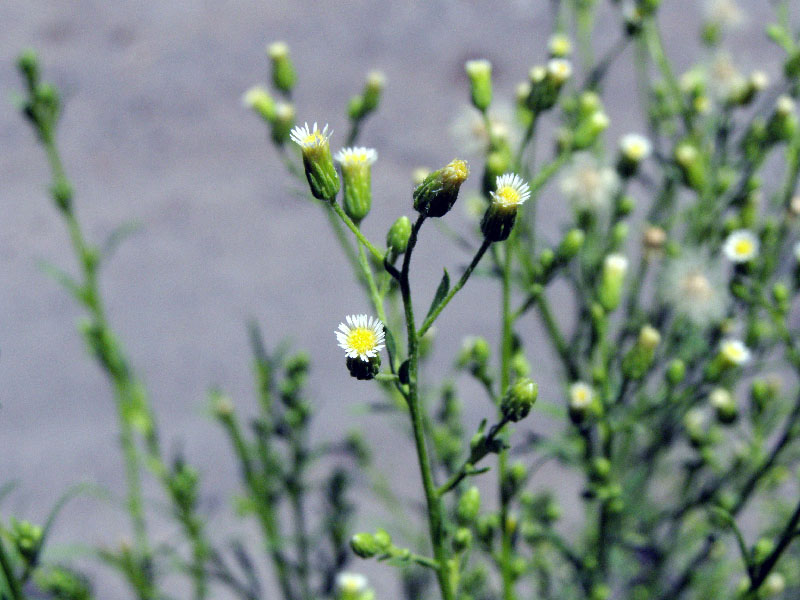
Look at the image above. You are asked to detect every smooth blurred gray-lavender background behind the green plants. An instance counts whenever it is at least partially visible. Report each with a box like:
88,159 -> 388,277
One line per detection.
0,0 -> 778,599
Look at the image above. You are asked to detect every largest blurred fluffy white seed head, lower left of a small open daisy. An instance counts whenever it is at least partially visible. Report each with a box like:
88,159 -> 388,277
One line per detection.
659,250 -> 728,327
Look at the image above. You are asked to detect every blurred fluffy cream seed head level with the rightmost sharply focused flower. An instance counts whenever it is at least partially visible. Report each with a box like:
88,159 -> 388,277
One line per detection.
560,152 -> 620,212
